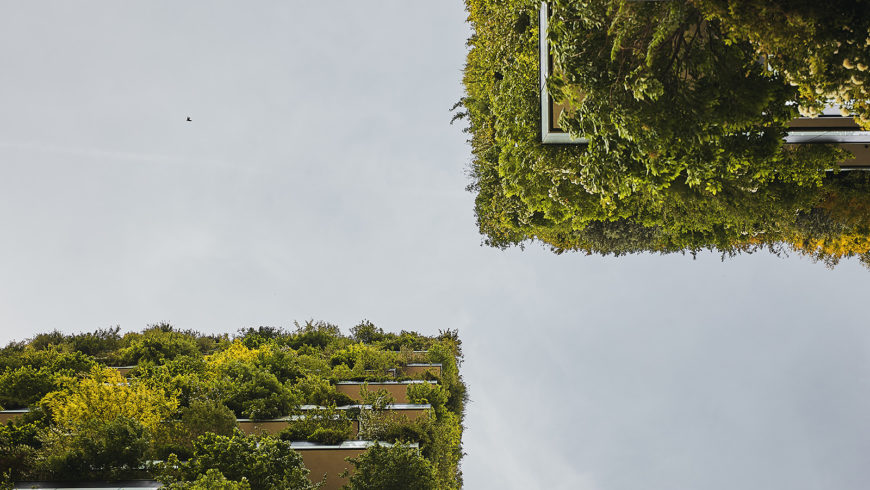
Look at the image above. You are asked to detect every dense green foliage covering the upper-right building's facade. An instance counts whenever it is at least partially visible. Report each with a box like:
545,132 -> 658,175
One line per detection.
457,0 -> 870,263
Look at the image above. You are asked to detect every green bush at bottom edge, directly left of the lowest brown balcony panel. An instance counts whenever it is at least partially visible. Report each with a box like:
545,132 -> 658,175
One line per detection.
158,430 -> 315,490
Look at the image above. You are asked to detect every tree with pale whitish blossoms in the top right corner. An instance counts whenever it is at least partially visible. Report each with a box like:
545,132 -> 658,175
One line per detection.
691,0 -> 870,129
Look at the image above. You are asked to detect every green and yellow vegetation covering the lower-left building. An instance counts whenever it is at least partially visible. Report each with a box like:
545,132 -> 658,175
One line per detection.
0,322 -> 466,489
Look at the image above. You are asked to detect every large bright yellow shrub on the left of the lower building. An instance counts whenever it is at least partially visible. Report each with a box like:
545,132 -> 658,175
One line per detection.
45,366 -> 178,430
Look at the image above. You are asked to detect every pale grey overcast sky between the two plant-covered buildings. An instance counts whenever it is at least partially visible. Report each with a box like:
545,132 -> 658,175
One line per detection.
0,0 -> 870,490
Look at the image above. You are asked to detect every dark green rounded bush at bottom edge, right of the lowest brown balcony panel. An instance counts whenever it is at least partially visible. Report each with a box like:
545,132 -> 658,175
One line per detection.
344,444 -> 441,490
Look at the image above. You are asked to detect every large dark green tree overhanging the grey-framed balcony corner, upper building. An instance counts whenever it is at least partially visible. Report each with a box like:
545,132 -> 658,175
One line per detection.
548,0 -> 836,195
